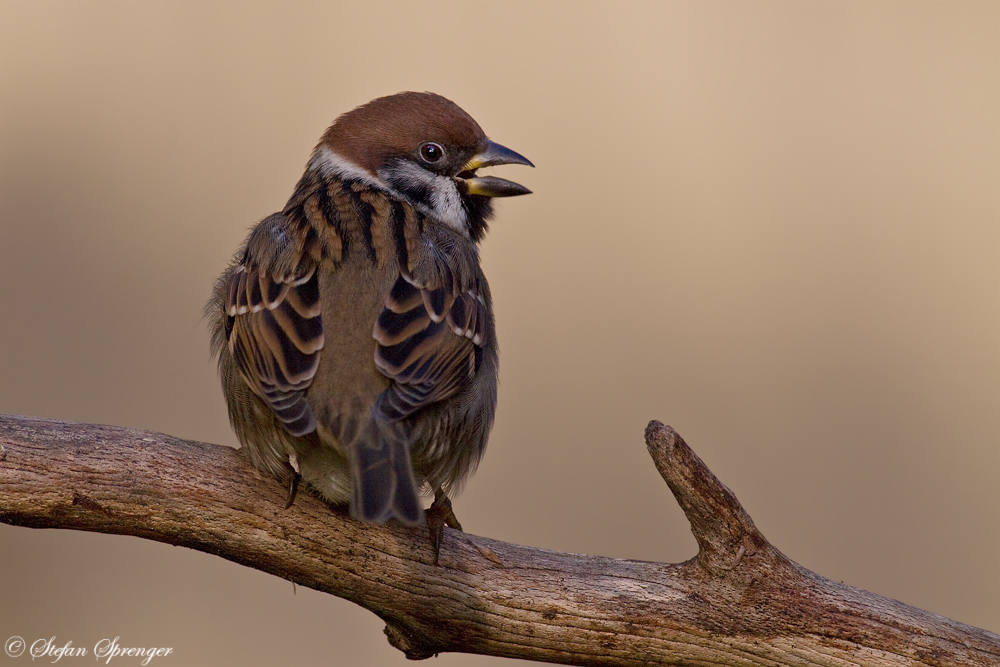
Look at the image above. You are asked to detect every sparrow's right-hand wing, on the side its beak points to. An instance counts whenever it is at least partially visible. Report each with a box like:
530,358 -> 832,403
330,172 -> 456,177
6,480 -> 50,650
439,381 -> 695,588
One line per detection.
373,228 -> 492,420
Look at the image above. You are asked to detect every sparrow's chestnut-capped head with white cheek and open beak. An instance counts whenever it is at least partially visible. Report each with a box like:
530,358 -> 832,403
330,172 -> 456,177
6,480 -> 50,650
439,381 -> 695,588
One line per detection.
310,93 -> 534,241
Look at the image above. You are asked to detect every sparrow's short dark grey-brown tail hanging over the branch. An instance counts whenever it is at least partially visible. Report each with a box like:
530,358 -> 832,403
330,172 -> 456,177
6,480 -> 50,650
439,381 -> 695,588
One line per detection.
351,415 -> 424,525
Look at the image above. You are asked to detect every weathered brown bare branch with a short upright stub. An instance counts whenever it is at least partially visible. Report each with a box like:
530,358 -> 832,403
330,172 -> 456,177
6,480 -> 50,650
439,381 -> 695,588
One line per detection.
0,415 -> 1000,667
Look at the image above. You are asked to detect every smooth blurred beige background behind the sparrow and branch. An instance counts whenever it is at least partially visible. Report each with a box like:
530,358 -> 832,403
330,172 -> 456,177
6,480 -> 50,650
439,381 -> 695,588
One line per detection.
0,2 -> 1000,665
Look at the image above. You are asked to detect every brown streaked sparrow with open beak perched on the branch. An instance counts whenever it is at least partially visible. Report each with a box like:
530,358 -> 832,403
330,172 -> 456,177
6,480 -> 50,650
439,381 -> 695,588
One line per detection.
206,92 -> 534,563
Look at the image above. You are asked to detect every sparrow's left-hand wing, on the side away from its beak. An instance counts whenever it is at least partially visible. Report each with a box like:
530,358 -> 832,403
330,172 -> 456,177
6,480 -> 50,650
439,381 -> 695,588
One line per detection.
225,214 -> 323,435
